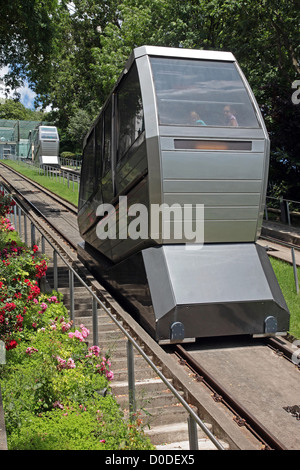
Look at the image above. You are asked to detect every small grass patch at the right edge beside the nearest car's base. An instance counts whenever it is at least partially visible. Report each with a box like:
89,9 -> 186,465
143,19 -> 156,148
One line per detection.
270,257 -> 300,338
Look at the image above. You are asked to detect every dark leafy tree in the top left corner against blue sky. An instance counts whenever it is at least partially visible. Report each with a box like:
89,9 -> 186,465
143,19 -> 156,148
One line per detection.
0,0 -> 59,93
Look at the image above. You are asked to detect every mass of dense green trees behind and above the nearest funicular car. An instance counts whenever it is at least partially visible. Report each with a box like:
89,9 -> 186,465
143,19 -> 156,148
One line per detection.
0,0 -> 300,199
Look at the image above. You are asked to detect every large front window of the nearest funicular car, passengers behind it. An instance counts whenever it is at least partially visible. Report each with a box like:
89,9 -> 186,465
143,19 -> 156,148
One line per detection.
150,57 -> 259,127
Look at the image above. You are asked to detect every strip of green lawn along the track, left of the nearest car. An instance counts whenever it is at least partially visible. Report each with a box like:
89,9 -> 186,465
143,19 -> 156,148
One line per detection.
3,160 -> 78,207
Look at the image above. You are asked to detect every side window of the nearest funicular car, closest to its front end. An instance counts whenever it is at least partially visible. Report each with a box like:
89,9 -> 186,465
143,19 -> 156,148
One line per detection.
118,65 -> 144,160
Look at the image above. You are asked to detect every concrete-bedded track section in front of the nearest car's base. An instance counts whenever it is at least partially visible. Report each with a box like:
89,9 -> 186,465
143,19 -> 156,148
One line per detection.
174,338 -> 300,450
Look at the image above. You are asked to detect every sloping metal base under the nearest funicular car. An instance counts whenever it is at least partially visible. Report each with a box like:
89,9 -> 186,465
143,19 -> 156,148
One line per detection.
79,243 -> 289,341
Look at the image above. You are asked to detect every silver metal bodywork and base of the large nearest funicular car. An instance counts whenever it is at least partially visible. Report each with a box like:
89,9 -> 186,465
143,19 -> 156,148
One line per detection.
78,46 -> 289,341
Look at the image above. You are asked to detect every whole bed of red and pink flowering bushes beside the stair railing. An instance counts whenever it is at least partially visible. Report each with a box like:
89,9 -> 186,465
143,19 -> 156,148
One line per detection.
0,199 -> 153,450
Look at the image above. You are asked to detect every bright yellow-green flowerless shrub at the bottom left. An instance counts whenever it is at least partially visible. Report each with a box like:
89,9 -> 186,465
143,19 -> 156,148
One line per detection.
9,396 -> 153,450
